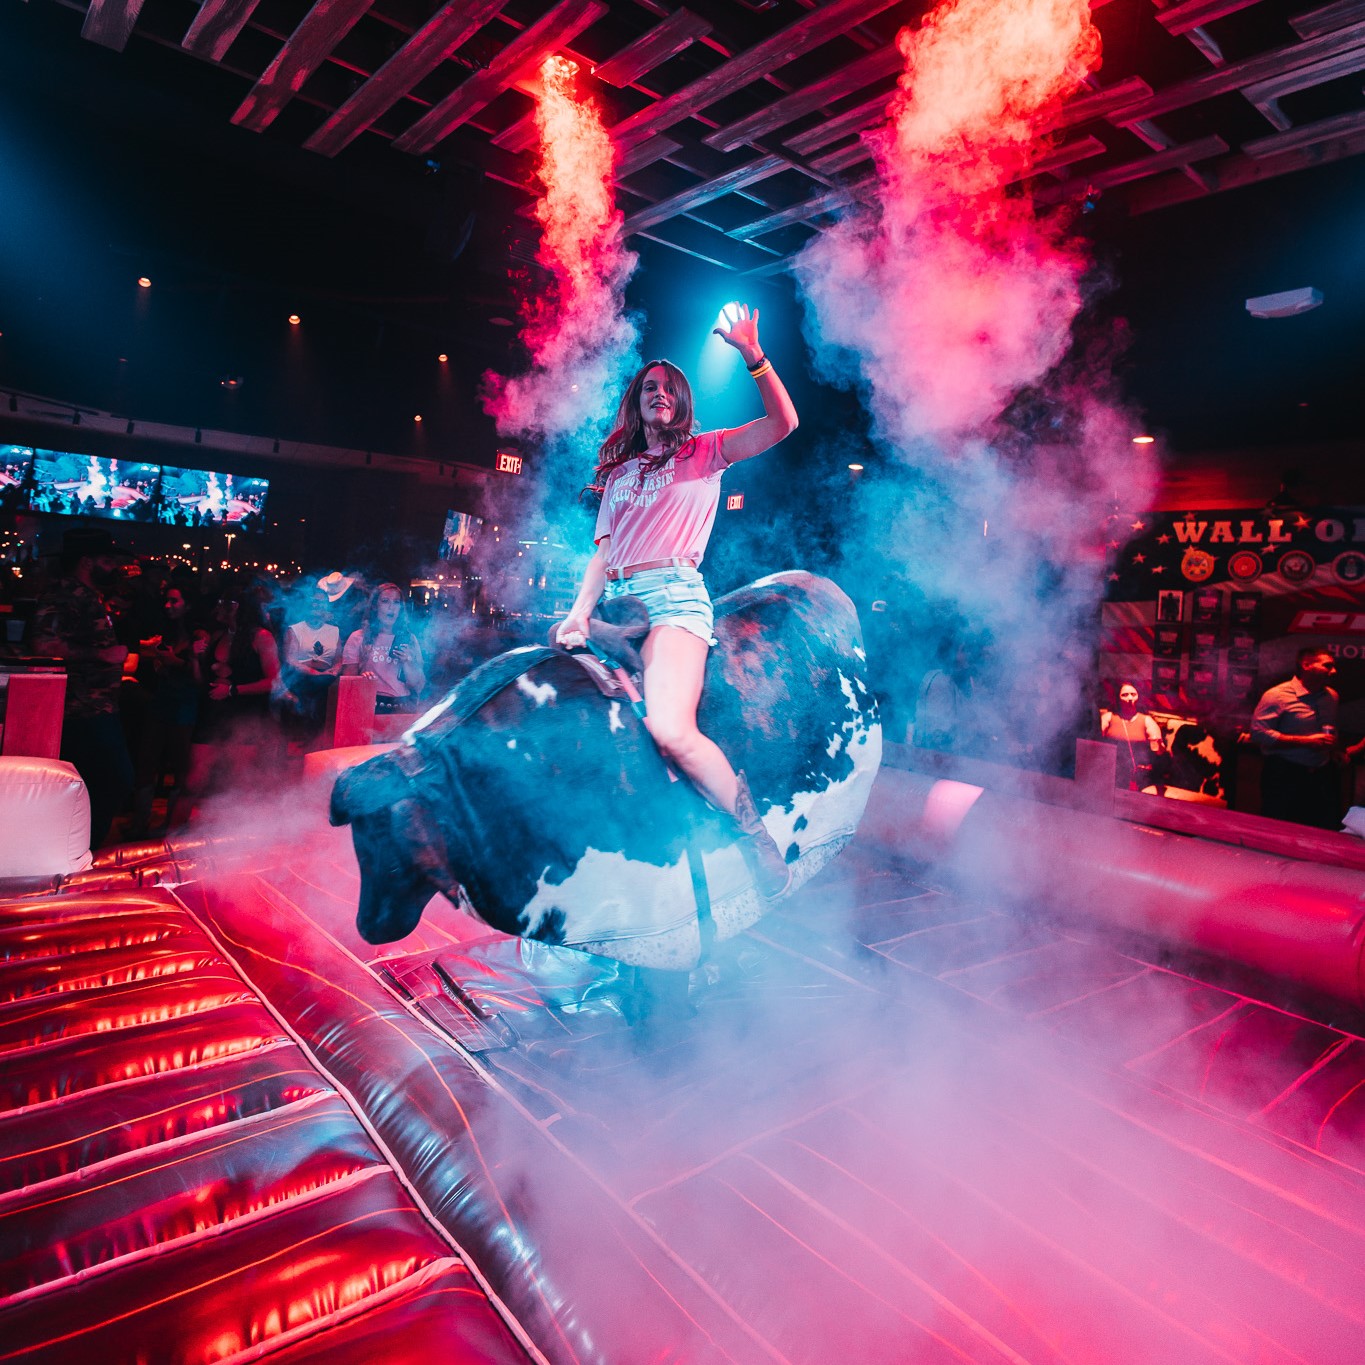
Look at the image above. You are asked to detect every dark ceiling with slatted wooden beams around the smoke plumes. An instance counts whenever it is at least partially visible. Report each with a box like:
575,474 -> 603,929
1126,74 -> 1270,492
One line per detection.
0,0 -> 1365,463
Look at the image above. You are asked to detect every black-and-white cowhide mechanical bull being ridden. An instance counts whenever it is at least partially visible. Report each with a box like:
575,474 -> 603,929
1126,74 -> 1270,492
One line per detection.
332,572 -> 882,971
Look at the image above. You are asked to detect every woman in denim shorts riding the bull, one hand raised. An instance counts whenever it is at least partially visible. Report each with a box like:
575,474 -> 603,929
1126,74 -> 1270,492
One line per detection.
556,303 -> 797,897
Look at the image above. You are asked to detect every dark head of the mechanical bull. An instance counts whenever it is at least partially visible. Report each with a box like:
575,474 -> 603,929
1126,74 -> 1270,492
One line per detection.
330,748 -> 459,943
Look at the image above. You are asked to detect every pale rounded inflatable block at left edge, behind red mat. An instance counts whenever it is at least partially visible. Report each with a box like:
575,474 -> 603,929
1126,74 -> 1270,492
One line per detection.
0,756 -> 90,882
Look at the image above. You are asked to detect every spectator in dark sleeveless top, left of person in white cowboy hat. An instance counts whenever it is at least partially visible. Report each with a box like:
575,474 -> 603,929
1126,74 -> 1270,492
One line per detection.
190,587 -> 280,792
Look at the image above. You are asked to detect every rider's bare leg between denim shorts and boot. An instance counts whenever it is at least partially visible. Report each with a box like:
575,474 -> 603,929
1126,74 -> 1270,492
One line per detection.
640,625 -> 737,815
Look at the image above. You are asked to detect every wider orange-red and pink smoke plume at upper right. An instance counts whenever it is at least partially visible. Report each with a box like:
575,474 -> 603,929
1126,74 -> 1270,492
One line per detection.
797,0 -> 1099,448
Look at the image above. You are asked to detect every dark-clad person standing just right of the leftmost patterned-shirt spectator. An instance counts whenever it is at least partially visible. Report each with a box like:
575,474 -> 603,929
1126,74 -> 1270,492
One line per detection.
128,586 -> 209,838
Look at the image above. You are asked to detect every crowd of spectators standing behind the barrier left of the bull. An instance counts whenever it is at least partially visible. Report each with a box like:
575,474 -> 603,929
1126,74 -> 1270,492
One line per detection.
25,528 -> 442,848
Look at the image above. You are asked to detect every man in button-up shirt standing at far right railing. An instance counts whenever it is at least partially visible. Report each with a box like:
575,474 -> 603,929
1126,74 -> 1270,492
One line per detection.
1252,646 -> 1365,830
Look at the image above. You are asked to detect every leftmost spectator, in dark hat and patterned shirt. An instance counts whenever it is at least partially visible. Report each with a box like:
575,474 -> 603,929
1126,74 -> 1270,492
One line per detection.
33,527 -> 132,849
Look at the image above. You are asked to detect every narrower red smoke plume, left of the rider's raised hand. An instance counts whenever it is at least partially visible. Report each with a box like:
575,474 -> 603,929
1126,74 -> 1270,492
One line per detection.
485,57 -> 636,437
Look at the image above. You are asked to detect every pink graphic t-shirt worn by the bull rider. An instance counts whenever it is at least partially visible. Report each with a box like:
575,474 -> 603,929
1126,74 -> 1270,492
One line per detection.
594,431 -> 730,569
